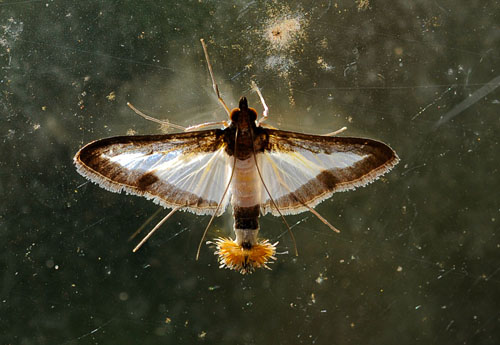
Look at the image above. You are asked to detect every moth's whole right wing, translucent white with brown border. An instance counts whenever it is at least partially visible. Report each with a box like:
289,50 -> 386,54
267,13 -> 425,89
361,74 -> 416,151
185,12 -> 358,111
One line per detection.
257,129 -> 399,215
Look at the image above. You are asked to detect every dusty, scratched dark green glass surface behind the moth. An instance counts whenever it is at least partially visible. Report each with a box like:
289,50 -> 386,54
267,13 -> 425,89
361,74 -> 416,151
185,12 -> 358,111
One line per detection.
0,0 -> 500,344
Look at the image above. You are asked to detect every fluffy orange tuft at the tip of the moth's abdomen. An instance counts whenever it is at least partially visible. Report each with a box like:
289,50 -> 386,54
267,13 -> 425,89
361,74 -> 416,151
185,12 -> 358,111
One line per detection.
214,237 -> 278,274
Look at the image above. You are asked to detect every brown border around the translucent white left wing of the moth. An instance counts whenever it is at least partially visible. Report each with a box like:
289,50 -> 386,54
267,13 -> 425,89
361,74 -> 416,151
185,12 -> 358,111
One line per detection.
74,129 -> 225,214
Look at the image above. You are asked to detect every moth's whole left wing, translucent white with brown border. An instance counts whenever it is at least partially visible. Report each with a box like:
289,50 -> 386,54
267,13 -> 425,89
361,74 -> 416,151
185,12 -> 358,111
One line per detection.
74,129 -> 232,215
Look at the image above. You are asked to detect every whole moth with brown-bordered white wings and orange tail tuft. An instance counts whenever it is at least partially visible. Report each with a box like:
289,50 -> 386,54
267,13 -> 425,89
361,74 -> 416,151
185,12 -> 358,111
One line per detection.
74,39 -> 399,274
